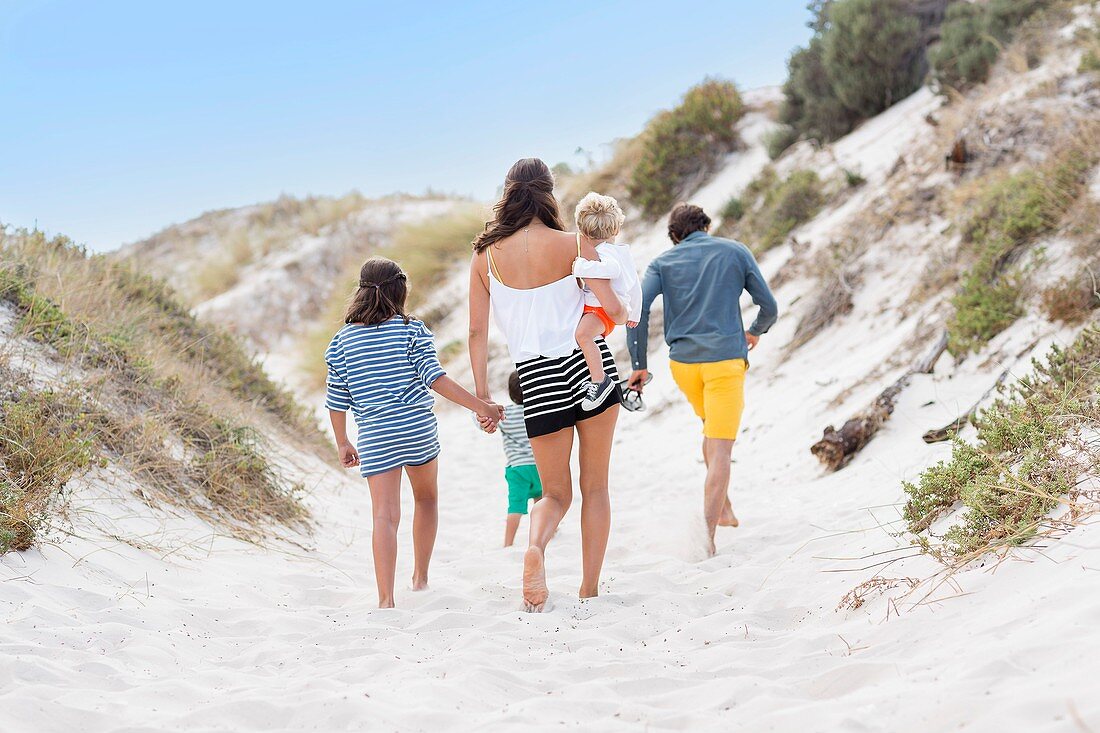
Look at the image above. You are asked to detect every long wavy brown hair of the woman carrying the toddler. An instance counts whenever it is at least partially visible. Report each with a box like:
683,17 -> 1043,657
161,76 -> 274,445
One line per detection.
474,157 -> 565,252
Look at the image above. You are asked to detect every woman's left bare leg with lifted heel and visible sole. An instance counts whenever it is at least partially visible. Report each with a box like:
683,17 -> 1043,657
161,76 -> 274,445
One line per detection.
524,428 -> 573,612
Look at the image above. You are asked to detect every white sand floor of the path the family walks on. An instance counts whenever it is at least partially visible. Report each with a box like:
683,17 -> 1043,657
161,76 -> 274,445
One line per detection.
0,305 -> 1100,731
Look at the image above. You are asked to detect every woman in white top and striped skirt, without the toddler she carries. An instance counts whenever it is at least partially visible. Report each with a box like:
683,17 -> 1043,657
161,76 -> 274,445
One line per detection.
470,157 -> 627,611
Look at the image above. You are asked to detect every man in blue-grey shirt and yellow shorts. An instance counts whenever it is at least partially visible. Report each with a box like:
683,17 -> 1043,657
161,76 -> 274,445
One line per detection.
627,204 -> 779,555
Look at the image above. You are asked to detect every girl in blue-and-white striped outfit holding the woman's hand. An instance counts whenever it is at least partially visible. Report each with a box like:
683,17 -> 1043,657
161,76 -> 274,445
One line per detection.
325,258 -> 504,609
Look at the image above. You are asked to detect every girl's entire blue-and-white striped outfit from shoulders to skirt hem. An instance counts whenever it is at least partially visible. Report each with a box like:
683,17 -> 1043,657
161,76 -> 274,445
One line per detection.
325,316 -> 444,477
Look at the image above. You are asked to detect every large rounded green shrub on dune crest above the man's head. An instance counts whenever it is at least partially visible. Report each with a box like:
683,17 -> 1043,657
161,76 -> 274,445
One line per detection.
627,79 -> 744,218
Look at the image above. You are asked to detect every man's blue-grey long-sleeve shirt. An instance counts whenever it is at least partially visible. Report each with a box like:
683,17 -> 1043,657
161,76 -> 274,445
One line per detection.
626,231 -> 779,369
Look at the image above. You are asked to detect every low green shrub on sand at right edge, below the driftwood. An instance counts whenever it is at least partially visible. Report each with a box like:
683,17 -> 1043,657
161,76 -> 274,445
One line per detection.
903,327 -> 1100,559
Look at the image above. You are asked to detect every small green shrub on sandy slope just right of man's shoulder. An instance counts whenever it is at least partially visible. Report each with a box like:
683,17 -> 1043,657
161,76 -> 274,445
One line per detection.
735,167 -> 825,254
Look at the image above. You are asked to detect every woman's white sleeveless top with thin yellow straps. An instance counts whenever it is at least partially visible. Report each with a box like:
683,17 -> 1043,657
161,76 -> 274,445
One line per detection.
485,245 -> 584,364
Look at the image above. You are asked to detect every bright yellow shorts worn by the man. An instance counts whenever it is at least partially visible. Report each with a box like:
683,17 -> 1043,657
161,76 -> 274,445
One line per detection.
670,359 -> 748,440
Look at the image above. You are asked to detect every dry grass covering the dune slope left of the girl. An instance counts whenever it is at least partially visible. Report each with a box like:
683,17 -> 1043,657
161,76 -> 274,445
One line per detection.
0,232 -> 323,545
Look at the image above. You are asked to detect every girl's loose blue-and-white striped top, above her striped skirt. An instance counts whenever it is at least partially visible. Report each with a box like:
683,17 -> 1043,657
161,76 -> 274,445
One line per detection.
325,316 -> 446,422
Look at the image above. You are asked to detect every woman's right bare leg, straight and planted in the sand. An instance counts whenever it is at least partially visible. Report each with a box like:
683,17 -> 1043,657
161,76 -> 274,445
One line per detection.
576,405 -> 619,598
